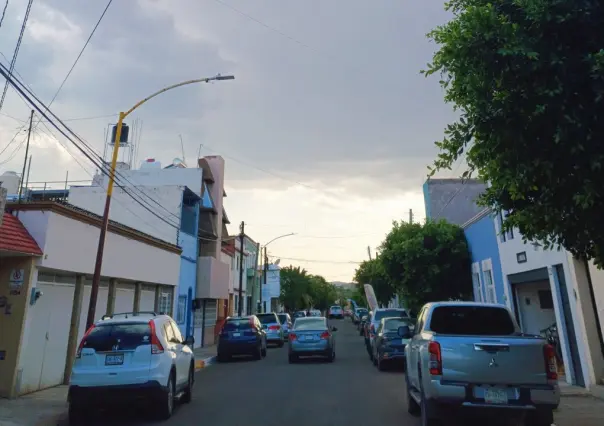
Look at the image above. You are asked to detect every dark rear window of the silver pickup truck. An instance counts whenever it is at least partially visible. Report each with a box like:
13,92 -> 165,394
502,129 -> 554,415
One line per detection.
429,306 -> 516,336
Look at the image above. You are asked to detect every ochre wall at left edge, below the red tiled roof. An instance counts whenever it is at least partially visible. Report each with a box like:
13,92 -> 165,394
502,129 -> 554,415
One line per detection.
0,257 -> 35,398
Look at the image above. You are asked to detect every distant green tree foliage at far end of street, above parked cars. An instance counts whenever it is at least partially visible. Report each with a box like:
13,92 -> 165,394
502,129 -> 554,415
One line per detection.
280,266 -> 337,310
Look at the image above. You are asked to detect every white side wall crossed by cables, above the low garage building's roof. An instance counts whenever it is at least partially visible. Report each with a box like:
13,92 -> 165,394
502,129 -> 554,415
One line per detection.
68,185 -> 184,244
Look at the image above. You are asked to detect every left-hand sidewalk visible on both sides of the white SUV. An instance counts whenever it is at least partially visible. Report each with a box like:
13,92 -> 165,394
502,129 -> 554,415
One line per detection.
0,345 -> 216,426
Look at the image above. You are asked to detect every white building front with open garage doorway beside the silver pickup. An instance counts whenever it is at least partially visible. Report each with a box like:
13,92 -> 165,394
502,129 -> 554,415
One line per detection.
495,218 -> 604,388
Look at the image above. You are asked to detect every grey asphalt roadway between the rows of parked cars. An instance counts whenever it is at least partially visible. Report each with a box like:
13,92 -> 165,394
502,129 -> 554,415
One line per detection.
41,319 -> 604,426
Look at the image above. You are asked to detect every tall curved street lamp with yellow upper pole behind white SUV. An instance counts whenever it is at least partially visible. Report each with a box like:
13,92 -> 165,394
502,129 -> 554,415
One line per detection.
86,74 -> 235,329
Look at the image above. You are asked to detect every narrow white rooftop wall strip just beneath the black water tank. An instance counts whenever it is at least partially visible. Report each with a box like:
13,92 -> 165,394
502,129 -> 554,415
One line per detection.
91,168 -> 203,196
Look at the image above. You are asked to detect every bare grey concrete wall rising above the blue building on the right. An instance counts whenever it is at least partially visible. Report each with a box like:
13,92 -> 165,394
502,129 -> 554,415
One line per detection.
423,179 -> 486,225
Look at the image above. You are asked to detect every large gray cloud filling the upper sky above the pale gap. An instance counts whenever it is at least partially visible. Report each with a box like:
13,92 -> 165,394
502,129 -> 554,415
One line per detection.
0,0 -> 454,196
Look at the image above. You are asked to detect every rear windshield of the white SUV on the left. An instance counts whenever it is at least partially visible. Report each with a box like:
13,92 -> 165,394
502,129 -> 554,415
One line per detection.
83,323 -> 151,352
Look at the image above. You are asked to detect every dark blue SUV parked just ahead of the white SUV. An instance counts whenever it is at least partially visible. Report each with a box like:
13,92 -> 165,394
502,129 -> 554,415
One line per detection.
216,315 -> 267,362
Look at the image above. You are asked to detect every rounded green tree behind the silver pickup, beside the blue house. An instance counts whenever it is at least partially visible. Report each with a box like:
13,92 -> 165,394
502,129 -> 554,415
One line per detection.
379,221 -> 472,312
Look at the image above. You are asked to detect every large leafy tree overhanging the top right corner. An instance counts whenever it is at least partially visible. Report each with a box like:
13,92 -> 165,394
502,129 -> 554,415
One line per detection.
424,0 -> 604,265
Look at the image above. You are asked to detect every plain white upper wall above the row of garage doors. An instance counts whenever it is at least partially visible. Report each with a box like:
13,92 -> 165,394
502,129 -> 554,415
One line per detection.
19,211 -> 180,286
